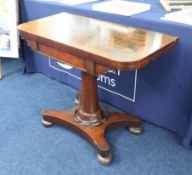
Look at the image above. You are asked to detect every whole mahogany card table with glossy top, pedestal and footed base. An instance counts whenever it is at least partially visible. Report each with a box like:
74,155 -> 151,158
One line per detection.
18,13 -> 178,164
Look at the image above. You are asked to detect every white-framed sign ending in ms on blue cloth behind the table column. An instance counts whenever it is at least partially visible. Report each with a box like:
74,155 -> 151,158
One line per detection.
49,59 -> 137,102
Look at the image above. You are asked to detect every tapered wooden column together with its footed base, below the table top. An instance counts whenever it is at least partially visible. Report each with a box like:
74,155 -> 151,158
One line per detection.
42,73 -> 141,164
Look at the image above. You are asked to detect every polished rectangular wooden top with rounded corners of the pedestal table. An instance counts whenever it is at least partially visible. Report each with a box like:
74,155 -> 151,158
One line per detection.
18,13 -> 178,70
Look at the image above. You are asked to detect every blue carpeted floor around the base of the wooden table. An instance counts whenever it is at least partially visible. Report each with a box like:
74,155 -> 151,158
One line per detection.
0,59 -> 192,175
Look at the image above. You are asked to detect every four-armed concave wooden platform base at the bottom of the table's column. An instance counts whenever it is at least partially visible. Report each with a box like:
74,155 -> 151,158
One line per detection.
42,109 -> 141,164
